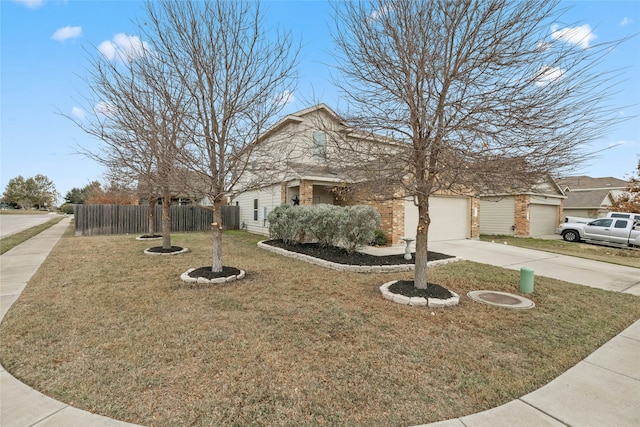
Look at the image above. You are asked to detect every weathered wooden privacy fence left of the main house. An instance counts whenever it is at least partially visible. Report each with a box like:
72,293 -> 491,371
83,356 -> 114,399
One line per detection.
73,205 -> 240,236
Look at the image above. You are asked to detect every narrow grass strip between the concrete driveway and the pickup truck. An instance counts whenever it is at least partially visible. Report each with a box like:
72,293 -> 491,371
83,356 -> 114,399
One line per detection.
480,235 -> 640,268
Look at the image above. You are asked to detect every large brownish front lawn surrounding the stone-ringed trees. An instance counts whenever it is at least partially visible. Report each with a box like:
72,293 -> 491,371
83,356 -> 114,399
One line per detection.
0,227 -> 640,426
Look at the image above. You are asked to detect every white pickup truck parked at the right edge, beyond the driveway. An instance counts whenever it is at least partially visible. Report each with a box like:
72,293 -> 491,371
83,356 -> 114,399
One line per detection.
556,218 -> 640,246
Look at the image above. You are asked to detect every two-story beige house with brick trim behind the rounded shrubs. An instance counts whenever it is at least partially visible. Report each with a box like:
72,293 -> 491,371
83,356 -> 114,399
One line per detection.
231,104 -> 480,244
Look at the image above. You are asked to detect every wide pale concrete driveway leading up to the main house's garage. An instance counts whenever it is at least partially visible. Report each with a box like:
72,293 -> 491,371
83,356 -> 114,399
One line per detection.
429,240 -> 640,296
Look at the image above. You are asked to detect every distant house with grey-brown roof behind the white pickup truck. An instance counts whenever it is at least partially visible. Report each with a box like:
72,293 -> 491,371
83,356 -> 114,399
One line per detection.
558,176 -> 629,218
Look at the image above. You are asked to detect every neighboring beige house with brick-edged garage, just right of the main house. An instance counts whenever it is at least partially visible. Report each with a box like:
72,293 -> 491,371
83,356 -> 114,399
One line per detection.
480,177 -> 566,237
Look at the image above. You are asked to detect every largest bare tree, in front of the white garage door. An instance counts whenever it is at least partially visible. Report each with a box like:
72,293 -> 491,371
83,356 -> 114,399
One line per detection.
334,0 -> 632,289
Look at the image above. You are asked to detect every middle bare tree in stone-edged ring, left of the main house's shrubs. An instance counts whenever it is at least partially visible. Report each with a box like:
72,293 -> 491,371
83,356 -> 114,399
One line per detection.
146,0 -> 298,272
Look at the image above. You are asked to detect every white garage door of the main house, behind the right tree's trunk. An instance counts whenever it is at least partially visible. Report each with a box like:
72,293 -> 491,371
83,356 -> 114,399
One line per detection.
404,197 -> 471,242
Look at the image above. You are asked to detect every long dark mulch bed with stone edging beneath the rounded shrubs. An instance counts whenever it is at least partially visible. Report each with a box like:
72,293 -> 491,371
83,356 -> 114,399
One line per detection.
263,240 -> 453,265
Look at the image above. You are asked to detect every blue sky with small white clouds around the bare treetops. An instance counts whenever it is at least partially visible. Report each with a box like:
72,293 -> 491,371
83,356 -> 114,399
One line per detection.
0,0 -> 640,202
